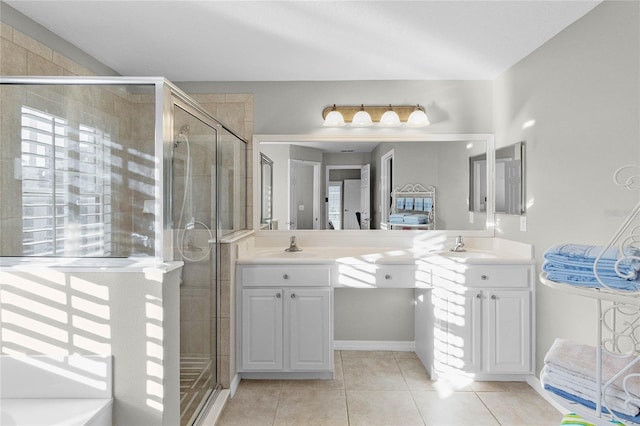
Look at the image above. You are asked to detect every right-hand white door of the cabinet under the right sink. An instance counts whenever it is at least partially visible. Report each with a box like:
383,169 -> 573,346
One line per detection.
485,290 -> 531,373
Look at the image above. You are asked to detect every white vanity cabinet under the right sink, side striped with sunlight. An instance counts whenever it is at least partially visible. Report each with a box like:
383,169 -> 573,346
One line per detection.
416,264 -> 533,378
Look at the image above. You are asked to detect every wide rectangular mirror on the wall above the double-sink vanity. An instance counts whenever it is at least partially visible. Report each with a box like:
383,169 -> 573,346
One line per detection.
253,134 -> 494,236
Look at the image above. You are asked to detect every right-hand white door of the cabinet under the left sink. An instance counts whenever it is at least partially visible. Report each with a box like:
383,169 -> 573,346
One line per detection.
285,288 -> 333,371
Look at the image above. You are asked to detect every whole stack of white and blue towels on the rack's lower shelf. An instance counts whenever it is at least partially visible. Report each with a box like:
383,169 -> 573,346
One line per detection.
540,339 -> 640,418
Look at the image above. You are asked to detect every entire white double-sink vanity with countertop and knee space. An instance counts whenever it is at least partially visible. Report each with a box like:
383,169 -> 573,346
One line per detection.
236,239 -> 535,380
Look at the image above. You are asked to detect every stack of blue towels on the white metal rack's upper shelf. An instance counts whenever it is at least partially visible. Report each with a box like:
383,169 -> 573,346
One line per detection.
542,244 -> 640,291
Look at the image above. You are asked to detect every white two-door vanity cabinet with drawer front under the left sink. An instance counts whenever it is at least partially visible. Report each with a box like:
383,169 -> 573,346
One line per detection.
238,265 -> 333,373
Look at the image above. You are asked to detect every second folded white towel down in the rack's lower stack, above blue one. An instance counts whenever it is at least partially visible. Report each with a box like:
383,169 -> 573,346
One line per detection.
540,364 -> 640,416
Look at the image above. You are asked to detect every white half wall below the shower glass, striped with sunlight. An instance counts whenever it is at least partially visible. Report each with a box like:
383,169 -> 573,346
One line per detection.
0,266 -> 181,425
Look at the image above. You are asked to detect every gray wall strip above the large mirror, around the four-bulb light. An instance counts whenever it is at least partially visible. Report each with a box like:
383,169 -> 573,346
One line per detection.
176,80 -> 493,134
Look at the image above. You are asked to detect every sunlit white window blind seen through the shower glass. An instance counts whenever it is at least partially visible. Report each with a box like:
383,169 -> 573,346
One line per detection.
21,107 -> 112,256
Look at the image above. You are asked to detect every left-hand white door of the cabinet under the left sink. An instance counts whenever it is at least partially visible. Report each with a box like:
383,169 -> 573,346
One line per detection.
242,288 -> 283,371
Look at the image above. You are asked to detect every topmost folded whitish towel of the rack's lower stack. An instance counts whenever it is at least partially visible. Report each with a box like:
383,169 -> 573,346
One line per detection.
544,339 -> 640,395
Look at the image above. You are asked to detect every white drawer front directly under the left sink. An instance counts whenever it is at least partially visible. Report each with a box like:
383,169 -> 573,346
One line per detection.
241,265 -> 331,287
